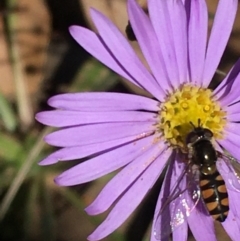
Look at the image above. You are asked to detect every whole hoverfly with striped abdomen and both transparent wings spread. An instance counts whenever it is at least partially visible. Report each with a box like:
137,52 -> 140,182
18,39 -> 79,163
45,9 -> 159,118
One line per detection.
154,119 -> 240,240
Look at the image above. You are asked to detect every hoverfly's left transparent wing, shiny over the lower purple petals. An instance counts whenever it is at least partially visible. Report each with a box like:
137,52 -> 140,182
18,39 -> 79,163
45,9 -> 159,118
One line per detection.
154,161 -> 201,240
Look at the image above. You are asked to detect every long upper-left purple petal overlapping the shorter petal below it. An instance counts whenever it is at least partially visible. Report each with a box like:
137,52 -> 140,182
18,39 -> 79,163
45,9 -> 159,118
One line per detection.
91,9 -> 165,100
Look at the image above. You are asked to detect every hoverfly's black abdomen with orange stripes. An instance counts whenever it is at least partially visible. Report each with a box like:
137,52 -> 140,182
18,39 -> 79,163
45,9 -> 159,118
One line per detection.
200,170 -> 229,222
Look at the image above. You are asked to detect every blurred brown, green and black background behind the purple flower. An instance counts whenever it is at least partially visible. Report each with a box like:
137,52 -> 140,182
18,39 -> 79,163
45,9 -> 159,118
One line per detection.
0,0 -> 240,241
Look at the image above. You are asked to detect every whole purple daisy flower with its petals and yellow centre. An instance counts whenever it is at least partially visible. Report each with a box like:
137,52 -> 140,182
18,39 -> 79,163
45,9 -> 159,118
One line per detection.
36,0 -> 240,241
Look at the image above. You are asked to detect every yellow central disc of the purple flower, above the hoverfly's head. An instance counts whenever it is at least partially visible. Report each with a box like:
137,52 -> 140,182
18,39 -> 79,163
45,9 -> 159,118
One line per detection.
157,84 -> 226,151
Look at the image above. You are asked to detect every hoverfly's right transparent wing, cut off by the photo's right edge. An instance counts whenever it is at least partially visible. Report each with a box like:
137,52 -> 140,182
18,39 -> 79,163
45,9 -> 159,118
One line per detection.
219,153 -> 240,192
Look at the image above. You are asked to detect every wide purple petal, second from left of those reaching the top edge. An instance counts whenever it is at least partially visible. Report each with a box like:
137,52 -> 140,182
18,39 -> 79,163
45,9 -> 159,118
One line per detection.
148,0 -> 180,86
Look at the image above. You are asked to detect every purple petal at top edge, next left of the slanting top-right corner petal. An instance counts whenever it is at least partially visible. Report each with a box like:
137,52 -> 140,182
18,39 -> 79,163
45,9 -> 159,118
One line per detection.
188,0 -> 208,84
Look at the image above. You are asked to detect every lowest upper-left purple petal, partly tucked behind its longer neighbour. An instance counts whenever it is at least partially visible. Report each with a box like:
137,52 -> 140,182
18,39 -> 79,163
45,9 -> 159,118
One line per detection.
69,26 -> 140,87
